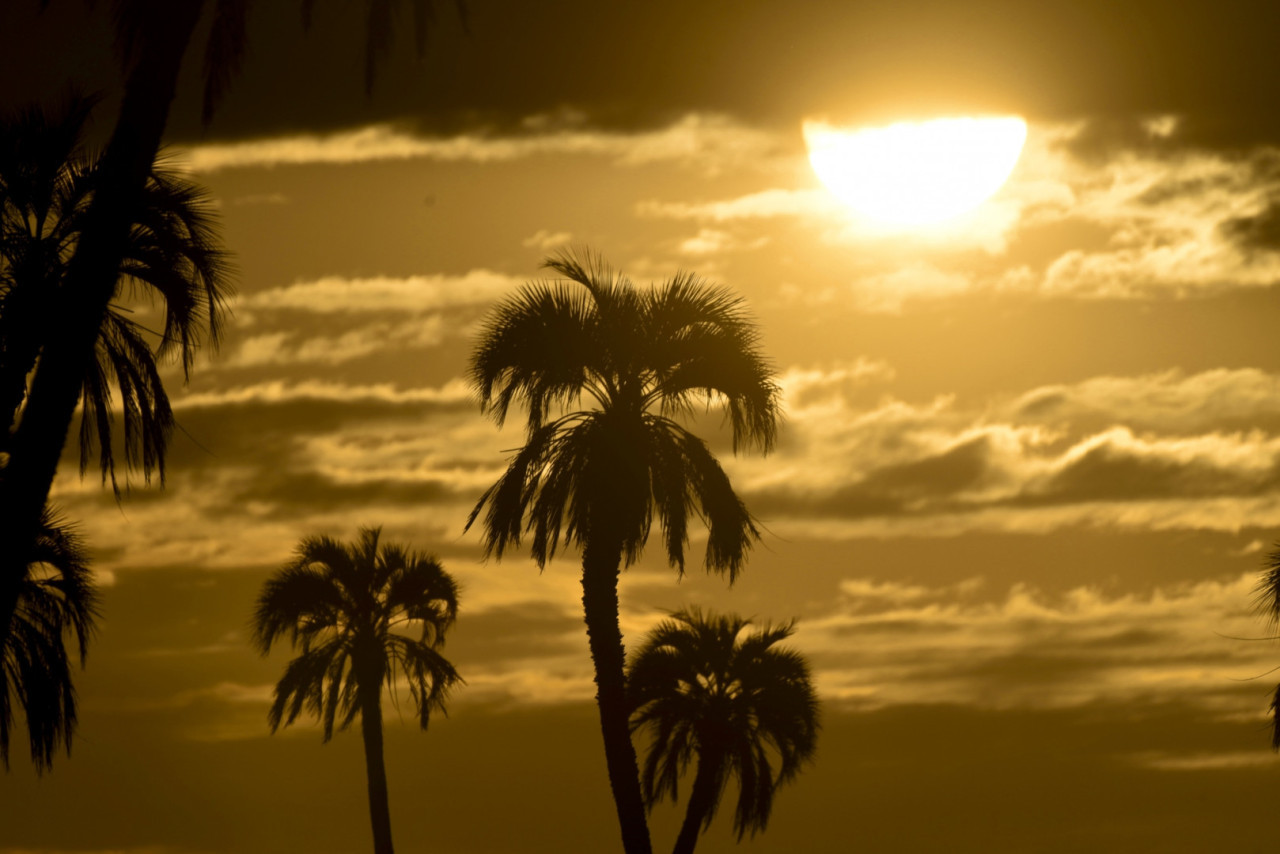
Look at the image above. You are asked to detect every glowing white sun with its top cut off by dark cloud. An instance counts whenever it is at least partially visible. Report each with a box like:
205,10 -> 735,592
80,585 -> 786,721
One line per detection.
804,117 -> 1027,227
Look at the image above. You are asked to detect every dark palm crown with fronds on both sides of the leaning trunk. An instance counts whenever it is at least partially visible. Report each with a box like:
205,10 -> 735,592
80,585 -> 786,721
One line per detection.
0,96 -> 229,492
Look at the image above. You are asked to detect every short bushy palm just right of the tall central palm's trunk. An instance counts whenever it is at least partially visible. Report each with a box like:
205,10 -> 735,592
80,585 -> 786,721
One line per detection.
627,608 -> 818,854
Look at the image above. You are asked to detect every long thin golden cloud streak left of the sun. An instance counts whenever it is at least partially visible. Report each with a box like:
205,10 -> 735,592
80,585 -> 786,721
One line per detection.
174,113 -> 778,173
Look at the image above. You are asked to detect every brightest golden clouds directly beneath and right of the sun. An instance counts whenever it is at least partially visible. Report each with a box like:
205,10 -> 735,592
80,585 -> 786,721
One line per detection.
635,117 -> 1280,312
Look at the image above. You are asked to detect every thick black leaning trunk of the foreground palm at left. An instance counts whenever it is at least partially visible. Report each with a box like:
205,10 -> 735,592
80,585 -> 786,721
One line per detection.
0,0 -> 204,644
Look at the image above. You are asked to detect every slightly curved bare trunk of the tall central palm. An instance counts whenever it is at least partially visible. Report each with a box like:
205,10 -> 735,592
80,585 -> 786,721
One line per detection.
582,536 -> 653,854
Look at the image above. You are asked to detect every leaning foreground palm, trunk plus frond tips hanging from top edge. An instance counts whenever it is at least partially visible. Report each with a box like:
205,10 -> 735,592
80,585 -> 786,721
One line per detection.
0,0 -> 462,676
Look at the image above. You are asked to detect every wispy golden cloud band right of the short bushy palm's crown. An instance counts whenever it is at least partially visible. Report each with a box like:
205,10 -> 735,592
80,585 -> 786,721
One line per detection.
796,574 -> 1275,720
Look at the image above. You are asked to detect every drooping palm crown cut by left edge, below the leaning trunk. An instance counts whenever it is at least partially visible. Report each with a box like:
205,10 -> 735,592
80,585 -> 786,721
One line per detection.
0,512 -> 97,772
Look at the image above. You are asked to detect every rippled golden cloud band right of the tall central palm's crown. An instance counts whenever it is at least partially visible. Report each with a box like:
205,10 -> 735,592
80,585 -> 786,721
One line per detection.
726,361 -> 1280,535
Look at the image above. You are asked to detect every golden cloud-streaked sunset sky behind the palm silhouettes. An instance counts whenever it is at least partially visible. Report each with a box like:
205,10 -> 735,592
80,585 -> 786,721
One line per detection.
0,0 -> 1280,854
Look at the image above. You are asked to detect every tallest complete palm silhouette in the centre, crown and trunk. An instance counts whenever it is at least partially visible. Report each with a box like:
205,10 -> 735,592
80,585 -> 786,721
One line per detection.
467,254 -> 778,854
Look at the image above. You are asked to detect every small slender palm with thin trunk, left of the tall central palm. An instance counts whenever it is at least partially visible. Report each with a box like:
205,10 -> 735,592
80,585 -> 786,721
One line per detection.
252,528 -> 462,854
